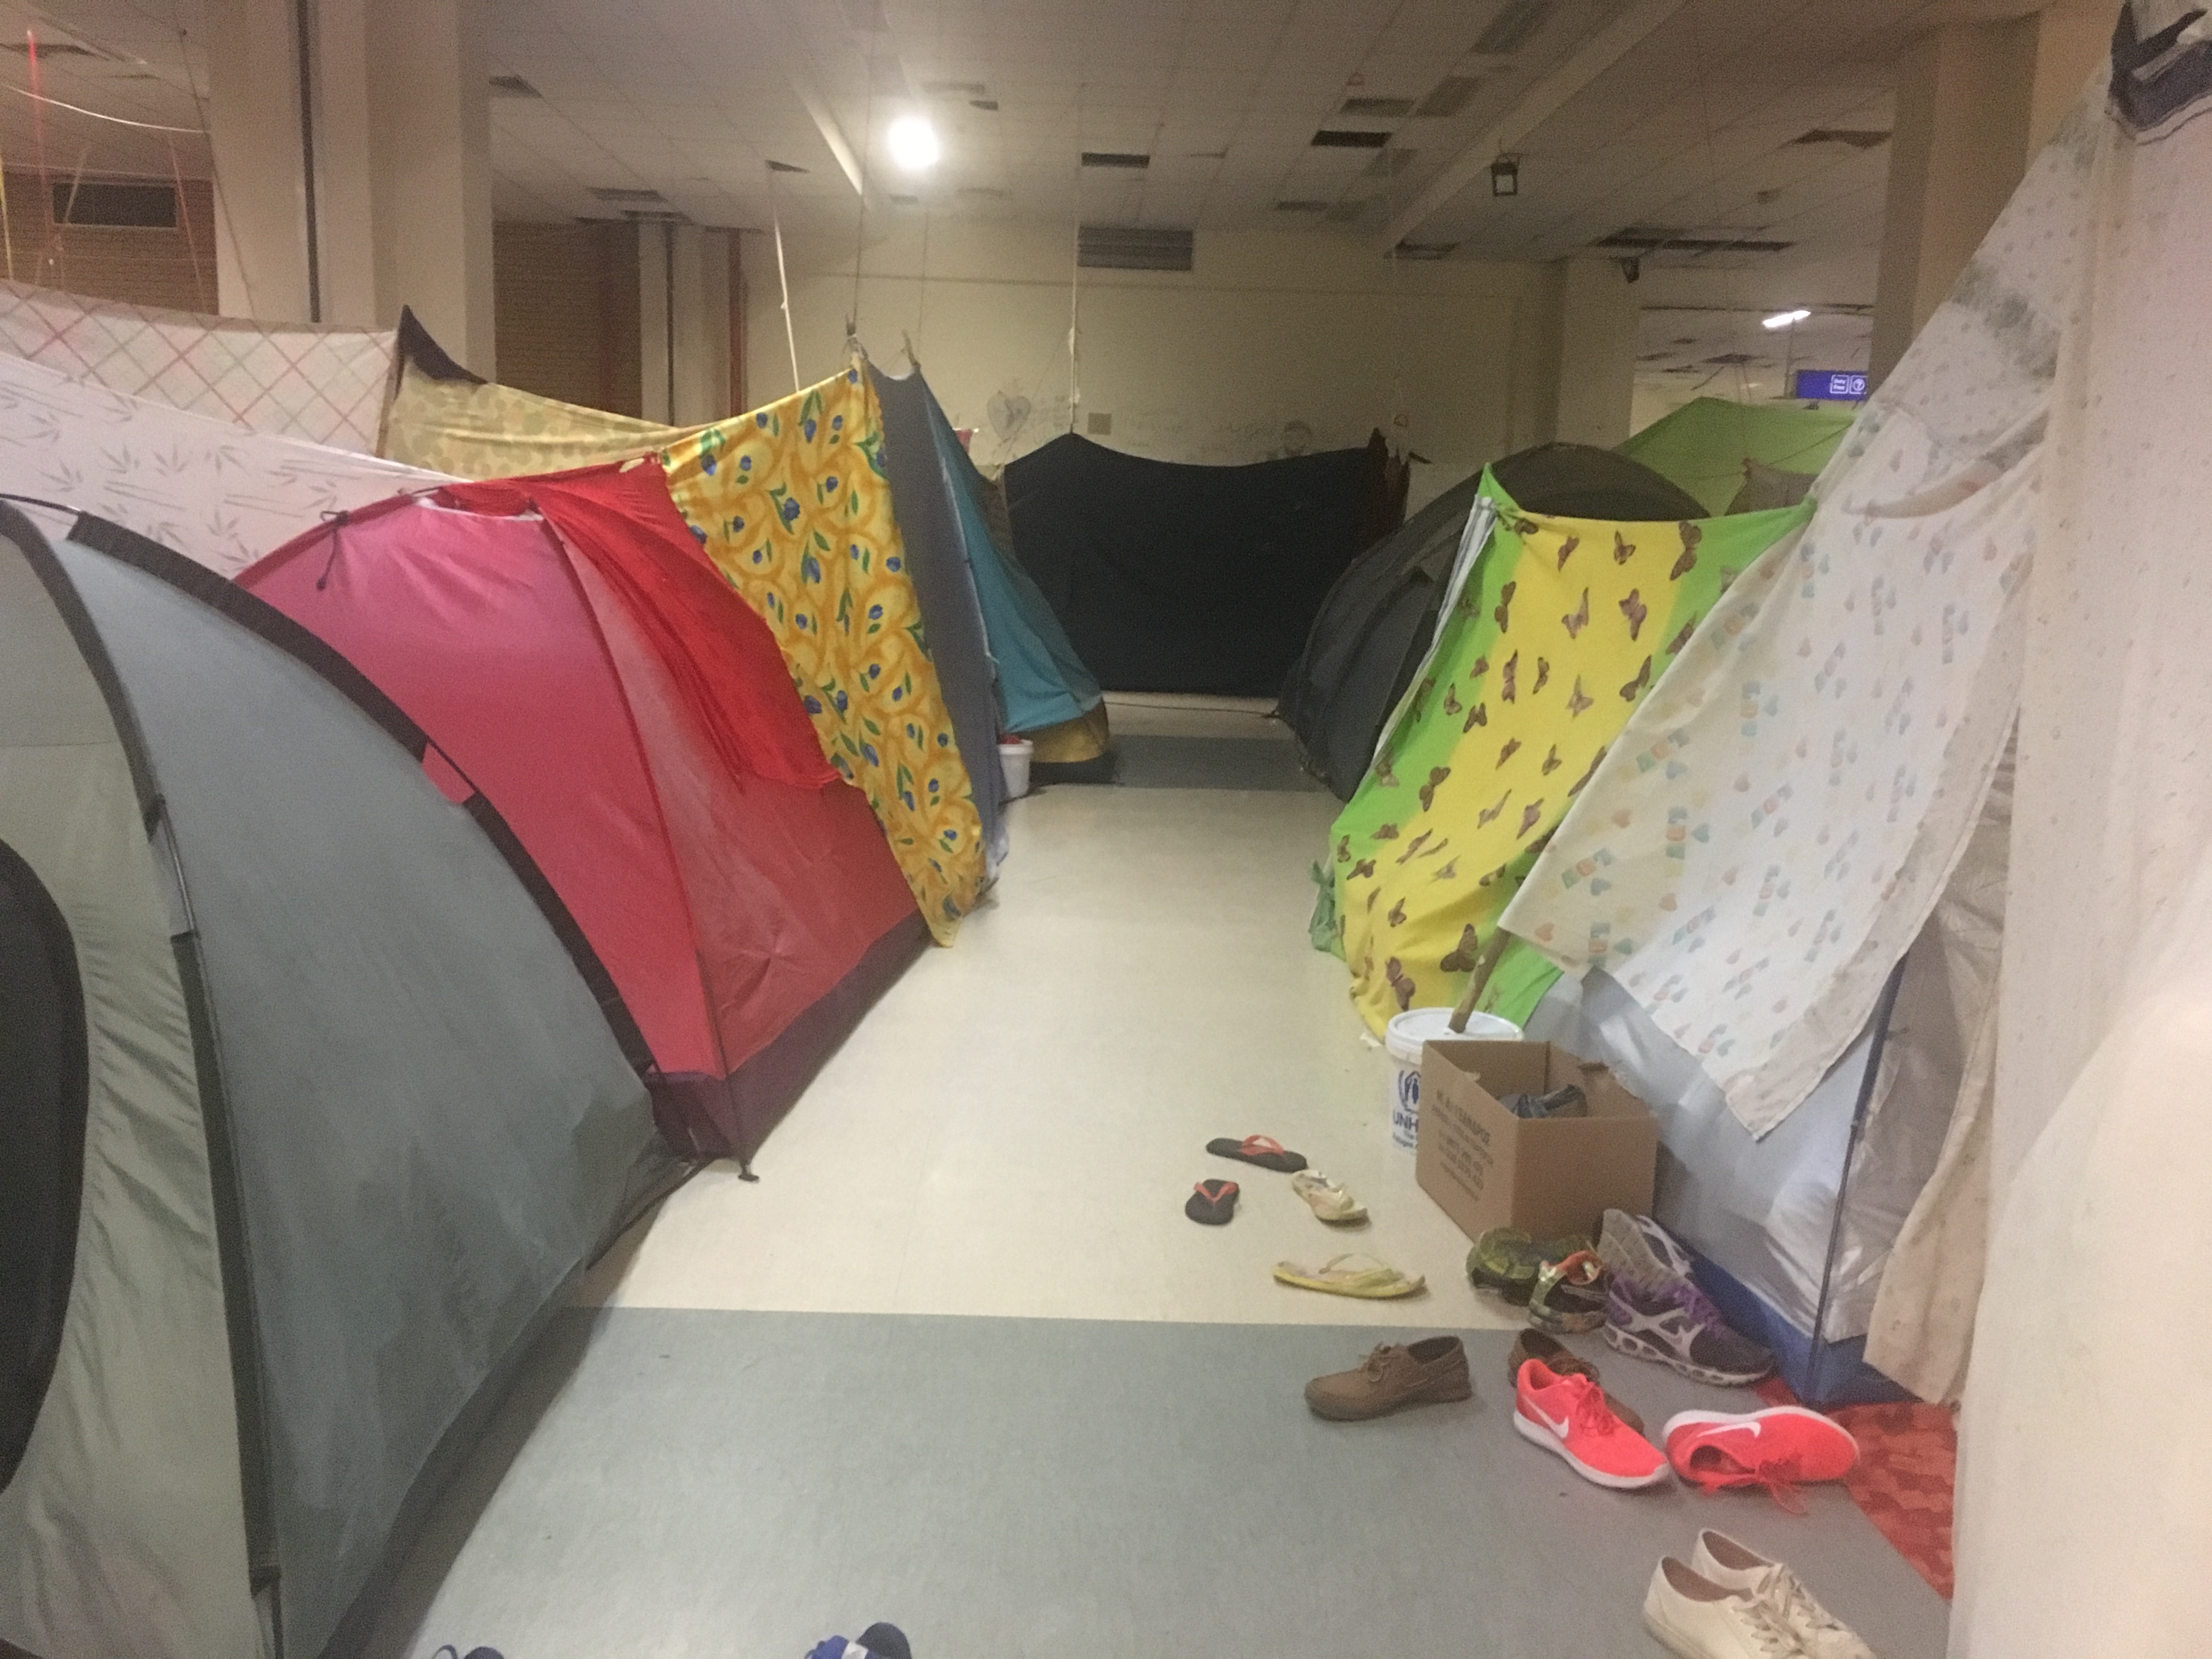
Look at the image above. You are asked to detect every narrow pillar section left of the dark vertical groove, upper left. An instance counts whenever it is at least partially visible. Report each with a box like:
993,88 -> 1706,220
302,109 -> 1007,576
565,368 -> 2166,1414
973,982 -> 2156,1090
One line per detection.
208,0 -> 309,319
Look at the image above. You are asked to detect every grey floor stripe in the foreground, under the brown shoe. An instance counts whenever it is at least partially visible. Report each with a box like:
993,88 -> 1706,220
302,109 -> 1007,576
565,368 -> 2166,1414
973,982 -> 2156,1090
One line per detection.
374,1310 -> 1946,1659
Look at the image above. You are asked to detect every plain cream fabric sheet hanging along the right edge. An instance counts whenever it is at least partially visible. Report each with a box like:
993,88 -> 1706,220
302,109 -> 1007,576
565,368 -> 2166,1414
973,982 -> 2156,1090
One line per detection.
1951,0 -> 2212,1659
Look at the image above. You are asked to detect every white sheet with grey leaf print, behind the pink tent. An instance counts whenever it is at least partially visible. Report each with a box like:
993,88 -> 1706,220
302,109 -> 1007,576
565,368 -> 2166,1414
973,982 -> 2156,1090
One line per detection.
0,354 -> 447,575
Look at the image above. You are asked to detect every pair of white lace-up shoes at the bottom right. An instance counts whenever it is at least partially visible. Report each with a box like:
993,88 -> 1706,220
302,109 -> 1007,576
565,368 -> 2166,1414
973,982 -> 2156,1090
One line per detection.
1644,1528 -> 1876,1659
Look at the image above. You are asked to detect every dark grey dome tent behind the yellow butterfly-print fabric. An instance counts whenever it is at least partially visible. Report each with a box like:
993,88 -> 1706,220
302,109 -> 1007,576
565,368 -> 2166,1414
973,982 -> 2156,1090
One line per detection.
1276,444 -> 1706,801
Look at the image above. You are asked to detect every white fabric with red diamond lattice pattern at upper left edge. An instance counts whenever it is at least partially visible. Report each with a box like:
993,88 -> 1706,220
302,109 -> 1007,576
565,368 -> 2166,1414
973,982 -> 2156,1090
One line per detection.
0,281 -> 394,456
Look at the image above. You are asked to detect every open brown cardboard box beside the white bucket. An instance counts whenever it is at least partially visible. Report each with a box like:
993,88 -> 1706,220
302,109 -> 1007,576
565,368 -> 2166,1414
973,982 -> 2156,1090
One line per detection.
1413,1042 -> 1659,1239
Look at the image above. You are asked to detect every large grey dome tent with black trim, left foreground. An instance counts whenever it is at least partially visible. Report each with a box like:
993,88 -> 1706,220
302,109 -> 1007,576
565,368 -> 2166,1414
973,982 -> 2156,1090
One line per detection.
0,506 -> 675,1659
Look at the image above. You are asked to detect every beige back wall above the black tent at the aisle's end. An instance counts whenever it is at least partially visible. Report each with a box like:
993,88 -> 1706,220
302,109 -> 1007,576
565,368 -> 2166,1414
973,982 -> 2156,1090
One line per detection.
746,217 -> 1566,504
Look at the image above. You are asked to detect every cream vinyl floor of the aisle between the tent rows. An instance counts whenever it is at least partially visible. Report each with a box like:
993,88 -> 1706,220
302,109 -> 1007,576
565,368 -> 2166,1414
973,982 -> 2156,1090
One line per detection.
582,701 -> 1513,1329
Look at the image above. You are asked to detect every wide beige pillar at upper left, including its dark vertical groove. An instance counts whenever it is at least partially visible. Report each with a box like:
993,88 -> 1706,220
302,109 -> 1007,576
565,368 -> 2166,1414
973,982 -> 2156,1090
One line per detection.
208,0 -> 498,378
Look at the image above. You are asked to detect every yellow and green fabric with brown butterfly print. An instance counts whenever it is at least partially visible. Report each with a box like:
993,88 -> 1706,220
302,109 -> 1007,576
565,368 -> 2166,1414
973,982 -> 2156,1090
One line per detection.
1331,478 -> 1805,1031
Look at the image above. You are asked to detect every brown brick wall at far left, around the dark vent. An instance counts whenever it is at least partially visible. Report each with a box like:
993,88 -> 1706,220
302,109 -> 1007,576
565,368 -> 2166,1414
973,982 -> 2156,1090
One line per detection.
0,168 -> 217,312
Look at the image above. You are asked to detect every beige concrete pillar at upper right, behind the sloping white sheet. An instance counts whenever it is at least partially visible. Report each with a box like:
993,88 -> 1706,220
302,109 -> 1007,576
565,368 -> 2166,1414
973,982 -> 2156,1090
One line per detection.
1871,0 -> 2119,383
